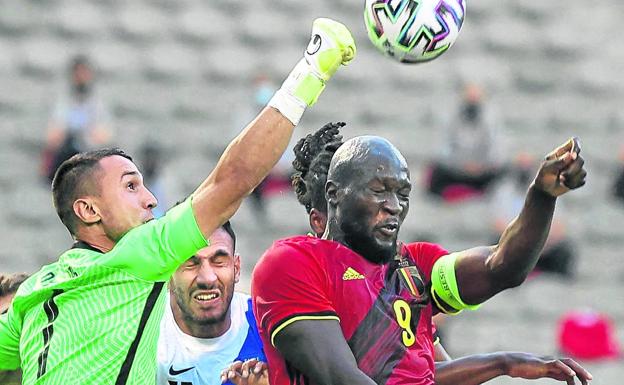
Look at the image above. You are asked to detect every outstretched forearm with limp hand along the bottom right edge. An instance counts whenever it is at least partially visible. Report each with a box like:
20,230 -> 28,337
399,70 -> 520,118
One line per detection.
435,352 -> 592,385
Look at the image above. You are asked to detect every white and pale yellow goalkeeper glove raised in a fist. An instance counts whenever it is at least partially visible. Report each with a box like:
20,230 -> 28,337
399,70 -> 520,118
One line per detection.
269,18 -> 356,125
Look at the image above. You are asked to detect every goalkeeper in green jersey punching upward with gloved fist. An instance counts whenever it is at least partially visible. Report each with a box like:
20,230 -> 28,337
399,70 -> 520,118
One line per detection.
0,19 -> 355,385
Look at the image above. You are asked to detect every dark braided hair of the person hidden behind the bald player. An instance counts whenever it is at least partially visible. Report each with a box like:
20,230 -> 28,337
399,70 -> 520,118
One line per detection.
292,122 -> 346,214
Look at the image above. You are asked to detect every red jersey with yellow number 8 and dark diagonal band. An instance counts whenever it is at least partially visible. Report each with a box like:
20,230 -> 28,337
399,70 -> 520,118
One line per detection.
251,236 -> 448,385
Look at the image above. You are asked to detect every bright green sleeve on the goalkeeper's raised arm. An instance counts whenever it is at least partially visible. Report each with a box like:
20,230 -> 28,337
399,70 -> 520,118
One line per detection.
103,198 -> 208,281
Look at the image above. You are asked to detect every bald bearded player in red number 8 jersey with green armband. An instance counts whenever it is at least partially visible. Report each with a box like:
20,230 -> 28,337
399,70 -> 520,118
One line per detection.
252,124 -> 590,385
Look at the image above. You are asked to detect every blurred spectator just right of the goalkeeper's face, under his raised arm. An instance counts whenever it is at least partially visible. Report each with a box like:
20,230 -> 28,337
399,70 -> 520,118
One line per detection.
140,143 -> 169,218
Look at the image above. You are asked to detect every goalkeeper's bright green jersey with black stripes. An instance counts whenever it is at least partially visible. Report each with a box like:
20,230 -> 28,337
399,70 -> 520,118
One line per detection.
0,199 -> 208,385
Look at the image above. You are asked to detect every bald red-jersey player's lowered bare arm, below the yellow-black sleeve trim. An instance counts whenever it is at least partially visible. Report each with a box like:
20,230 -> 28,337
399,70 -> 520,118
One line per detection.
275,320 -> 375,385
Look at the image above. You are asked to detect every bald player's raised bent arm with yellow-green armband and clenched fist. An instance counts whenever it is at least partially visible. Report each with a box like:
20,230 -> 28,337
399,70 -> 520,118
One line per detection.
432,138 -> 587,313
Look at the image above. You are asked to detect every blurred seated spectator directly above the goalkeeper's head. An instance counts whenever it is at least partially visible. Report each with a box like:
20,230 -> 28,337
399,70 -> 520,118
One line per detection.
41,55 -> 111,180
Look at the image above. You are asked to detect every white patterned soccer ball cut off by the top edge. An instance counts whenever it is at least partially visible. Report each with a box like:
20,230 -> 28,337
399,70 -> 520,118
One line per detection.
364,0 -> 466,63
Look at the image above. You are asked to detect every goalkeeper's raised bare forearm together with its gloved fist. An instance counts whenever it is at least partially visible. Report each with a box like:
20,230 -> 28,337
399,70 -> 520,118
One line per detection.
193,19 -> 355,238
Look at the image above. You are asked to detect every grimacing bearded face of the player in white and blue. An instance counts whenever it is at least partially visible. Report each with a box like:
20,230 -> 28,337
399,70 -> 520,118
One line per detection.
171,228 -> 240,338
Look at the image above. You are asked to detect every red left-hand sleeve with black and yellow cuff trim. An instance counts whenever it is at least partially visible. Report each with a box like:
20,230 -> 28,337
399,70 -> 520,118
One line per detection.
251,240 -> 339,346
